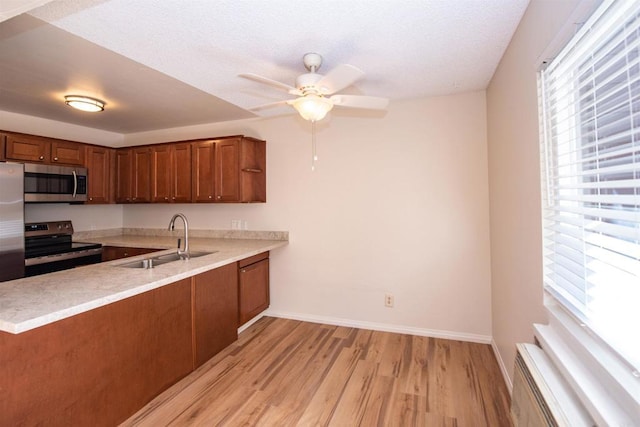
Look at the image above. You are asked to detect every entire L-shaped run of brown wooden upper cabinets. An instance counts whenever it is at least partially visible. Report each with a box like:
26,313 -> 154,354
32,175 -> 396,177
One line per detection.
0,132 -> 267,204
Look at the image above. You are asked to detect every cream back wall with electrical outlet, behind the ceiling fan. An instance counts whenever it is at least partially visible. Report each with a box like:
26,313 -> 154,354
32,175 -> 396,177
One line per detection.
16,92 -> 491,341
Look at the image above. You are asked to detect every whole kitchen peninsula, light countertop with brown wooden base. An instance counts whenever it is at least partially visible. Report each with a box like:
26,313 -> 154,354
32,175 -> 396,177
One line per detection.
0,230 -> 288,425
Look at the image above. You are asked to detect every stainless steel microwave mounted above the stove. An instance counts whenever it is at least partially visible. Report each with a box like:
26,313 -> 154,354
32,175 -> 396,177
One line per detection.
24,163 -> 87,203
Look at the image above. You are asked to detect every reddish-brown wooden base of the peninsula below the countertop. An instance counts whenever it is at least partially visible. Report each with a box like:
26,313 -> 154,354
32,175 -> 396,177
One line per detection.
0,256 -> 269,426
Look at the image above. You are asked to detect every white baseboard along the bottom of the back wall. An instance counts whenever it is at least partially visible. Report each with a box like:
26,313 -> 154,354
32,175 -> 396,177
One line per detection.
264,309 -> 492,344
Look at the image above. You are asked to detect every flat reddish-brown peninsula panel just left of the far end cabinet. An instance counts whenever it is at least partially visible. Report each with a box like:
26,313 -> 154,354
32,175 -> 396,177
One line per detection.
193,263 -> 238,367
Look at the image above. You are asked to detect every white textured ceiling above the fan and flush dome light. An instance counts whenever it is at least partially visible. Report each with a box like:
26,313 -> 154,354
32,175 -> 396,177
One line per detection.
0,0 -> 529,133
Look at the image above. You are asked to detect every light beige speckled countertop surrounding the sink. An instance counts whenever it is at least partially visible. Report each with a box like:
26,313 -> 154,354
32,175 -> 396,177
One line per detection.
0,229 -> 288,334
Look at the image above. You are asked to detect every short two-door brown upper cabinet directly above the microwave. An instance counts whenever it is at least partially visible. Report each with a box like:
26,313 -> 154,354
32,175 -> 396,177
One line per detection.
5,134 -> 84,166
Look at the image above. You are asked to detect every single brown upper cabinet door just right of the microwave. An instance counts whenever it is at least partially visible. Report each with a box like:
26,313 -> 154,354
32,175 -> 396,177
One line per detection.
85,145 -> 115,204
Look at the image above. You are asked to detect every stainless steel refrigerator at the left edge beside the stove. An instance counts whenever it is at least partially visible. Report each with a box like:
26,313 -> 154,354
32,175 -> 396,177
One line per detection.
0,162 -> 24,282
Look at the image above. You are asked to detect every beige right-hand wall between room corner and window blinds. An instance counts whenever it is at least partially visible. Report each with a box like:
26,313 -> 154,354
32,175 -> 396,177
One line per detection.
487,0 -> 579,386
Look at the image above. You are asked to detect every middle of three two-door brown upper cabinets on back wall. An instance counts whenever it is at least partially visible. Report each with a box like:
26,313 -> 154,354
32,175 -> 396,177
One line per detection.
151,142 -> 191,203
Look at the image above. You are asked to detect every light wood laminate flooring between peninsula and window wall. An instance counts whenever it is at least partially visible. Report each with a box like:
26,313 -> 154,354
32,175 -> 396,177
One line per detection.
122,317 -> 511,427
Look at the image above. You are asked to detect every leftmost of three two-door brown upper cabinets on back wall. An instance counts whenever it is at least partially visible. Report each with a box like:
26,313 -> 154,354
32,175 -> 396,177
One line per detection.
116,146 -> 151,203
